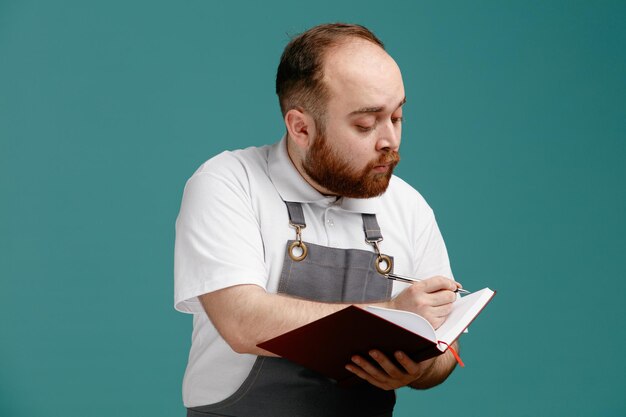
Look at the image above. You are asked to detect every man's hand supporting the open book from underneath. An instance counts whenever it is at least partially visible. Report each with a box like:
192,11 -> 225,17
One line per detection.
346,350 -> 436,390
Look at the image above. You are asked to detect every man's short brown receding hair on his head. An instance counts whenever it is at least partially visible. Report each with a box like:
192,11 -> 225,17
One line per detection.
276,23 -> 385,123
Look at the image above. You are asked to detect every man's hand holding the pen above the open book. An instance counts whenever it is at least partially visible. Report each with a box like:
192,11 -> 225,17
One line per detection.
386,276 -> 461,329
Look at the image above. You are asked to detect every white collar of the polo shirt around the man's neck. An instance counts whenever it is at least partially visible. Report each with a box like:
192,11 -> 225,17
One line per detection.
268,136 -> 380,213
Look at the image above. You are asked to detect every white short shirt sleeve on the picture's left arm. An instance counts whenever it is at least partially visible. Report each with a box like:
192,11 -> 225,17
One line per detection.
174,159 -> 267,313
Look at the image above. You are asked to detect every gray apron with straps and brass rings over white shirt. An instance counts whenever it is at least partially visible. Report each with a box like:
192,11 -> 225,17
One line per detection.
187,202 -> 396,417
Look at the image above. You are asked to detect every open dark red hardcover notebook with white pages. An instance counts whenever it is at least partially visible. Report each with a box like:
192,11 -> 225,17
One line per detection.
258,288 -> 495,385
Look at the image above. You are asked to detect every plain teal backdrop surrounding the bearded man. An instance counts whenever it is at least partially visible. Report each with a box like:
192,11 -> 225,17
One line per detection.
0,0 -> 626,417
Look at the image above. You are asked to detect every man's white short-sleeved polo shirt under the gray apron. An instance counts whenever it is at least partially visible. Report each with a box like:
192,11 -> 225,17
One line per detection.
174,138 -> 452,407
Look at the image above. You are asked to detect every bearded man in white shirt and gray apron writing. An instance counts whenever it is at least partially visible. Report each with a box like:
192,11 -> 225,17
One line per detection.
175,24 -> 460,416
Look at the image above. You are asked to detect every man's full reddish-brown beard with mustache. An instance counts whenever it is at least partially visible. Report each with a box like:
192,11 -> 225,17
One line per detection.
302,133 -> 400,198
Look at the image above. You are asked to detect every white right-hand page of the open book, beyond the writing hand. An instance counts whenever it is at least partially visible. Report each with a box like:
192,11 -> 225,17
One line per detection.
435,288 -> 493,344
